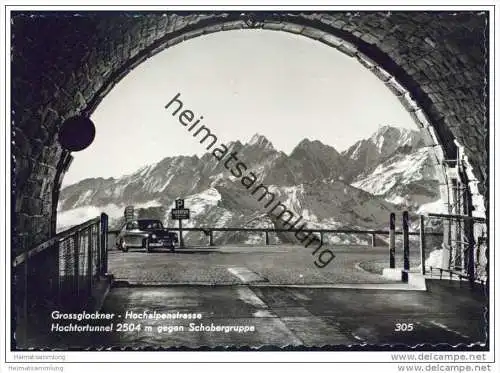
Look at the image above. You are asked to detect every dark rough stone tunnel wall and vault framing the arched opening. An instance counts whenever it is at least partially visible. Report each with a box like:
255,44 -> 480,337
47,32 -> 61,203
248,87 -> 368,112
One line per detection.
11,12 -> 488,250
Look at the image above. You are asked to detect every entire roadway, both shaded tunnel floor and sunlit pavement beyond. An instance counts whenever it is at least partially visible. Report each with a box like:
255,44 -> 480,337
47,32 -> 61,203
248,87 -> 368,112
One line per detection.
22,246 -> 488,350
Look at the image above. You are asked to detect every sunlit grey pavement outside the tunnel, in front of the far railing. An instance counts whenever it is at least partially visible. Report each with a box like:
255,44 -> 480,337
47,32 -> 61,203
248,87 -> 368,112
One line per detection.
109,245 -> 418,284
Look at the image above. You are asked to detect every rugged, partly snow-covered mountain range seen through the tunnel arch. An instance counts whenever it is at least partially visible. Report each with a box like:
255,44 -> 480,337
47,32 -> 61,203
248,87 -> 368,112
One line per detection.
58,126 -> 440,243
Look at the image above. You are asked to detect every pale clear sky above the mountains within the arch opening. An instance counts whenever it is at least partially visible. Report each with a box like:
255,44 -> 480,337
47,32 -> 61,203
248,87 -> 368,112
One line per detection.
63,30 -> 417,185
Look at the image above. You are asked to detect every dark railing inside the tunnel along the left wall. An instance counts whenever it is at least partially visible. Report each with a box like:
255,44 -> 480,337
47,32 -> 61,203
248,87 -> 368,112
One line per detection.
12,214 -> 108,342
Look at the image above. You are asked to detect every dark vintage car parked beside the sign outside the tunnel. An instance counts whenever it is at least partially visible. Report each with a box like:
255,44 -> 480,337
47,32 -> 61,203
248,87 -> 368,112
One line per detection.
116,219 -> 178,252
